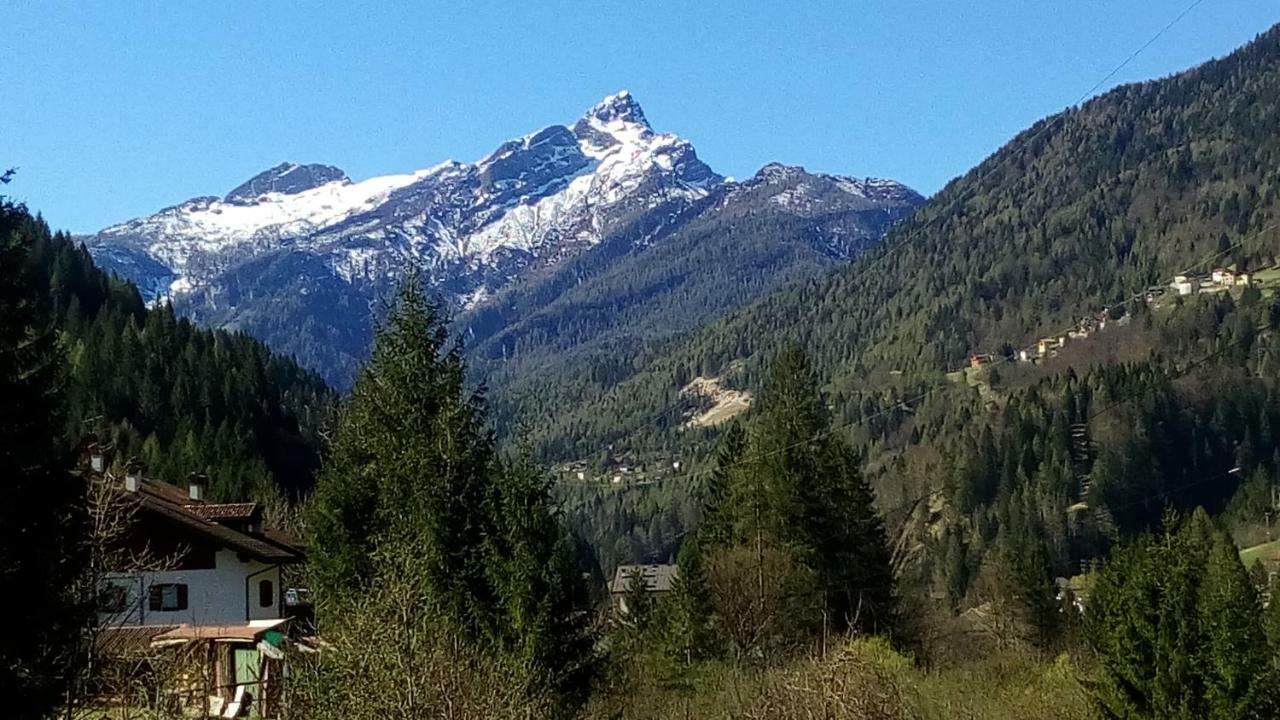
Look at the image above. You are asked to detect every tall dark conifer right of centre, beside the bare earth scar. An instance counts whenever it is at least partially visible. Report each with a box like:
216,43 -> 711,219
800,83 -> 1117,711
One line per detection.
695,346 -> 896,645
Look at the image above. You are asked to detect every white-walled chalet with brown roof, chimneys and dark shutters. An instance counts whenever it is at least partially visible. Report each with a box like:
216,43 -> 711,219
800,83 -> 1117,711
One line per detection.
87,446 -> 305,717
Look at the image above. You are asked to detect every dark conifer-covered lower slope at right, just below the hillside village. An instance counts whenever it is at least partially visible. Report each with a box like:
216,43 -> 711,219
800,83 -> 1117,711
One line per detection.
872,287 -> 1280,633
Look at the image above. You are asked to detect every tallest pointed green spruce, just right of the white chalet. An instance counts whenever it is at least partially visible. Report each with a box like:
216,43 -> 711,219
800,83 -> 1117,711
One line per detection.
312,283 -> 497,625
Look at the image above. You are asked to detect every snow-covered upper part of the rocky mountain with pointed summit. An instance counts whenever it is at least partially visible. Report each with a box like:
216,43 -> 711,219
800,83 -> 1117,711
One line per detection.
87,91 -> 722,302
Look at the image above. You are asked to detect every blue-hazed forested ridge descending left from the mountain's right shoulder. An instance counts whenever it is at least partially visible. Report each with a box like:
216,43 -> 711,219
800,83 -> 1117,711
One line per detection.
471,164 -> 922,427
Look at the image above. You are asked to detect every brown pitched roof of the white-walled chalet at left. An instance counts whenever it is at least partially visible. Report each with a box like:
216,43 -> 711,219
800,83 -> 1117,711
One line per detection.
137,479 -> 303,564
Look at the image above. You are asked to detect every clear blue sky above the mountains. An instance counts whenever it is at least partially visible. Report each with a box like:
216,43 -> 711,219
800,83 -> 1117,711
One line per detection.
0,0 -> 1280,232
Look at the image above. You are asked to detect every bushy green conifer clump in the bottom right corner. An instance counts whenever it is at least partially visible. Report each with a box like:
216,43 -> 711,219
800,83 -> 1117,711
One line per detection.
1087,511 -> 1276,720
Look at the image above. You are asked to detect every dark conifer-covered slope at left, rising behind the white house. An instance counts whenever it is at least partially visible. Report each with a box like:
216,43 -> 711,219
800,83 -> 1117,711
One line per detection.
0,205 -> 337,498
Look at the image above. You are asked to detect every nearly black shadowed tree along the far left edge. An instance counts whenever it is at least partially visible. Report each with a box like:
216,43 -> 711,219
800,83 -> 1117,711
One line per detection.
0,197 -> 88,719
